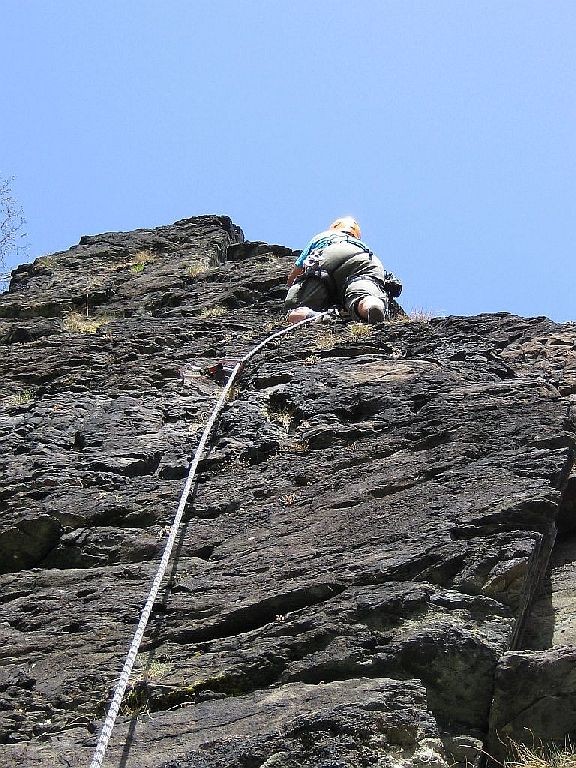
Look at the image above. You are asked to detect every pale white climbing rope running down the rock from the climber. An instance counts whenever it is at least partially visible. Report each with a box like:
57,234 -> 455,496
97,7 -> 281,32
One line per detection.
90,315 -> 323,768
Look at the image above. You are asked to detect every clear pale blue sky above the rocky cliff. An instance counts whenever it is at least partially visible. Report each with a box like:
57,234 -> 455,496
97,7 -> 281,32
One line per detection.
0,0 -> 576,321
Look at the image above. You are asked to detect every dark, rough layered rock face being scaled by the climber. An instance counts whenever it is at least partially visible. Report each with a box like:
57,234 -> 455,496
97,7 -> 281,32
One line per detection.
0,216 -> 576,768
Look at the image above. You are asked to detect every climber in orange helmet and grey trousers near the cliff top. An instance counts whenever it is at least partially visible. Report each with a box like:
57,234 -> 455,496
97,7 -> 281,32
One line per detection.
285,216 -> 402,324
